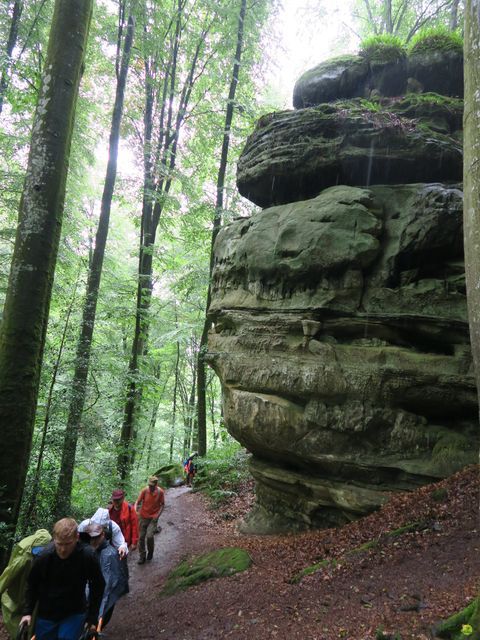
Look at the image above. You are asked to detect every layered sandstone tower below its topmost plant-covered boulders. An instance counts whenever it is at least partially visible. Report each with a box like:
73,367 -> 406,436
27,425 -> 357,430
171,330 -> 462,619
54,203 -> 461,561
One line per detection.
208,50 -> 478,532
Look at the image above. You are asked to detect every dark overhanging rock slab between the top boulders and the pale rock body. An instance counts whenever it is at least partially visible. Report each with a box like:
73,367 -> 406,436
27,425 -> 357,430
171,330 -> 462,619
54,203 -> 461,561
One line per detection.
237,98 -> 462,207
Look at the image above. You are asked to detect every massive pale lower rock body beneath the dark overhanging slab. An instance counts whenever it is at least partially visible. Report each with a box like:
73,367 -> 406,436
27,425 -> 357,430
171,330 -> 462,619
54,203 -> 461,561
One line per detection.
208,183 -> 478,532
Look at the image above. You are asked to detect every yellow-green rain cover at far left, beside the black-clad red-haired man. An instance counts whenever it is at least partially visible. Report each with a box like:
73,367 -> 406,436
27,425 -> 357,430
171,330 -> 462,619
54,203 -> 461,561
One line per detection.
0,529 -> 52,638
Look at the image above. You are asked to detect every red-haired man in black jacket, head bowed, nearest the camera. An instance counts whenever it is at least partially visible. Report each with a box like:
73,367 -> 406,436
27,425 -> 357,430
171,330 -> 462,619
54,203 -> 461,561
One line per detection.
20,518 -> 105,640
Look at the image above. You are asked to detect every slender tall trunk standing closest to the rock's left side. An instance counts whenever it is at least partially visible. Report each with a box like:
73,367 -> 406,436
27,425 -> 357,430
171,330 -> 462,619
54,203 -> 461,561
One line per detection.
197,0 -> 247,456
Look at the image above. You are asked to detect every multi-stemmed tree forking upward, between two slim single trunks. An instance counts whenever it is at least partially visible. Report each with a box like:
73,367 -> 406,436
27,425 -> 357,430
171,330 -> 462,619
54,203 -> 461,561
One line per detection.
118,0 -> 224,481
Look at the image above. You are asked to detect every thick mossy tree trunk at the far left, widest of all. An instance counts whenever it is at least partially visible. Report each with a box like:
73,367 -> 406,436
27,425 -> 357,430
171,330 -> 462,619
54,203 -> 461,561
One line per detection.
0,0 -> 92,552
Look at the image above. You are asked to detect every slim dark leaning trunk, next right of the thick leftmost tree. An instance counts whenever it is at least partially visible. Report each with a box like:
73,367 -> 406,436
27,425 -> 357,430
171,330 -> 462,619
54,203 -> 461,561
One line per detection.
54,16 -> 134,517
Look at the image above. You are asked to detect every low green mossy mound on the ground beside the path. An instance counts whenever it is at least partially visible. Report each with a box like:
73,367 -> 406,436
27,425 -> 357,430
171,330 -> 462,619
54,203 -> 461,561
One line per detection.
161,547 -> 252,596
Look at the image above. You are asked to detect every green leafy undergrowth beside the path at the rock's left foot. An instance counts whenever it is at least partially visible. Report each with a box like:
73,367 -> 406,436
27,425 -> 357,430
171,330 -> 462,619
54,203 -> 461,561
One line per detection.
193,443 -> 251,508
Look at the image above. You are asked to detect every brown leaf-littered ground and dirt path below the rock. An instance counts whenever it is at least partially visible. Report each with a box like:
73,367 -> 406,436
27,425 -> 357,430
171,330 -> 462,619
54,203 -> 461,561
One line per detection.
0,466 -> 480,640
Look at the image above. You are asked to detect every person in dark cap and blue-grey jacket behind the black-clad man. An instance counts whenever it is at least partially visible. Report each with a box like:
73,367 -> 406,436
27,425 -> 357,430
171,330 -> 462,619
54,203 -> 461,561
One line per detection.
85,523 -> 128,631
